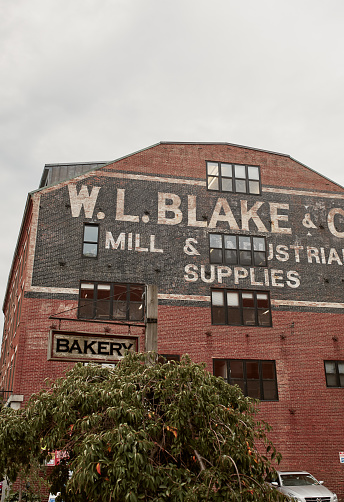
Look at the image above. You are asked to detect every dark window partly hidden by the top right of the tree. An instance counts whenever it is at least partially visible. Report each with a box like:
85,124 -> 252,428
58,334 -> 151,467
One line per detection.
213,359 -> 278,401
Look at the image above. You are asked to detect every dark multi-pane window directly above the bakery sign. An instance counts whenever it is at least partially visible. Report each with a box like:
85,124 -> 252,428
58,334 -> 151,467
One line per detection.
78,282 -> 144,321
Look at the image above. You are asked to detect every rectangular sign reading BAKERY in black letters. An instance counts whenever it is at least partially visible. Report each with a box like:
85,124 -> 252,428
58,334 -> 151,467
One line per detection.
48,330 -> 138,363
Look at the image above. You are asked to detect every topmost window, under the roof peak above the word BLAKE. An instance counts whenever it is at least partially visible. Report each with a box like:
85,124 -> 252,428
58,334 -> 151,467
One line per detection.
207,162 -> 260,195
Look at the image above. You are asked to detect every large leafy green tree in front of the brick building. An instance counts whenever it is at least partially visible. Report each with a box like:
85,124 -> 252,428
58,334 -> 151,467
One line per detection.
0,353 -> 283,502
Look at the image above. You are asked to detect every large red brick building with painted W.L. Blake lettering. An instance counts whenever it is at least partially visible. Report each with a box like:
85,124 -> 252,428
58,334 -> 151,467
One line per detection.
0,142 -> 344,496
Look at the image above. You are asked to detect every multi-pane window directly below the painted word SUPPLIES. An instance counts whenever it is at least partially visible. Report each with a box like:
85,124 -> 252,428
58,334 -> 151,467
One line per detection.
211,289 -> 271,326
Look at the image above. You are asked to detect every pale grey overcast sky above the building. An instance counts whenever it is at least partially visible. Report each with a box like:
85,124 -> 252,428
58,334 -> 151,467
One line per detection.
0,0 -> 344,334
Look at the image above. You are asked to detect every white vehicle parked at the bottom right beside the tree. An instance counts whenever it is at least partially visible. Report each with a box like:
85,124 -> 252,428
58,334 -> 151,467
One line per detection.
269,471 -> 338,502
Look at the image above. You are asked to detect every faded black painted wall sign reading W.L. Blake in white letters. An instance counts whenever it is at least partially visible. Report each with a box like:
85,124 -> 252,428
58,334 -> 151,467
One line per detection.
33,172 -> 344,310
